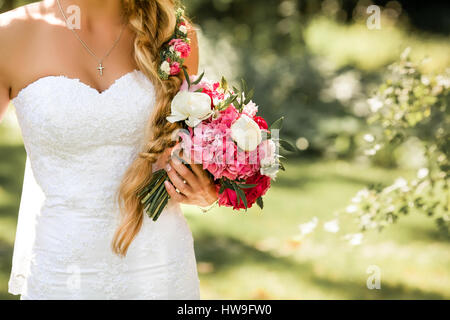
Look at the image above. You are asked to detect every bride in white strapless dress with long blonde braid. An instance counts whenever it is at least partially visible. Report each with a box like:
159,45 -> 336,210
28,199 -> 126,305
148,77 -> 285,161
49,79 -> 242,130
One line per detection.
0,0 -> 216,299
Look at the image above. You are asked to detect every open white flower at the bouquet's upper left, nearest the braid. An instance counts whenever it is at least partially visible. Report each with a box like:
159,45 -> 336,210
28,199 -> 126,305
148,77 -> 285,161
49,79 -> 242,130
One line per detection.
167,91 -> 213,127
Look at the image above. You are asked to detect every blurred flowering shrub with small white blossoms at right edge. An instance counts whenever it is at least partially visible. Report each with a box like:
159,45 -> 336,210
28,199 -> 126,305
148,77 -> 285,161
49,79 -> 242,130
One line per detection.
347,50 -> 450,236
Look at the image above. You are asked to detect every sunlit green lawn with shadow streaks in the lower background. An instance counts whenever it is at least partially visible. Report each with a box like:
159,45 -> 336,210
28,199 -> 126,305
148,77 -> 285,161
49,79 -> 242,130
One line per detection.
0,144 -> 450,299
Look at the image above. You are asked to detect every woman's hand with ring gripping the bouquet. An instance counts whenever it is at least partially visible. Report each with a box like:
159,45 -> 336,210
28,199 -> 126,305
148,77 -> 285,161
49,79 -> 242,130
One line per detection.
164,151 -> 217,207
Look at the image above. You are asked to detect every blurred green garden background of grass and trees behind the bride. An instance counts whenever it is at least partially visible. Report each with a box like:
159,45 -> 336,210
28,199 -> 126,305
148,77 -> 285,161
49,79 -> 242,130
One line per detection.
0,0 -> 450,299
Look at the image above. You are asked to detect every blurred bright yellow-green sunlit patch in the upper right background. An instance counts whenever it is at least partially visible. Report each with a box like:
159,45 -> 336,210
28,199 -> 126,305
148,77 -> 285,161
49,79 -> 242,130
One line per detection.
304,17 -> 450,72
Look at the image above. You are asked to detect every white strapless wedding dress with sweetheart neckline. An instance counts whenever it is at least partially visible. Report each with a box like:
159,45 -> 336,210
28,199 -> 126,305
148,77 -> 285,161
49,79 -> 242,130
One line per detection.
9,70 -> 200,299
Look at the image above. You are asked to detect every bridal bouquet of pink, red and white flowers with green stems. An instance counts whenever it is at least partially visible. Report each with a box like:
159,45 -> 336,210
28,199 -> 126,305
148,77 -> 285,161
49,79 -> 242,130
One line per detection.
139,69 -> 295,221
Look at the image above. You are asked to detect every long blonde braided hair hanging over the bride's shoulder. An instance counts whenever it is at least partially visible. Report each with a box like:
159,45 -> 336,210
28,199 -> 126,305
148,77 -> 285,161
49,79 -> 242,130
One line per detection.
112,0 -> 186,256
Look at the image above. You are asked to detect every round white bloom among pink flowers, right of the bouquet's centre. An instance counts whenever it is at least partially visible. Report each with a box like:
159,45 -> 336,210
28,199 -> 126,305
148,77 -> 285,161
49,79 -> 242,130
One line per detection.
231,114 -> 262,151
